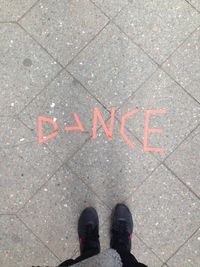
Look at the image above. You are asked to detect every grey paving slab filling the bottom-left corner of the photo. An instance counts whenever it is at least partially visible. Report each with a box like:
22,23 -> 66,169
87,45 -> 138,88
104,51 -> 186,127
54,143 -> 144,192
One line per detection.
0,215 -> 59,267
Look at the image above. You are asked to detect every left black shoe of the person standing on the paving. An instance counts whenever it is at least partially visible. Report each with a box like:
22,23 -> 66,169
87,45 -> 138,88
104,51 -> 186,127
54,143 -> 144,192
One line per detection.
78,207 -> 100,255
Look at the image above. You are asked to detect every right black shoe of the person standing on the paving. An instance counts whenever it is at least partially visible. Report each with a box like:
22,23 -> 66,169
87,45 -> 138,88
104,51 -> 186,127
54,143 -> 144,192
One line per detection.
110,204 -> 133,252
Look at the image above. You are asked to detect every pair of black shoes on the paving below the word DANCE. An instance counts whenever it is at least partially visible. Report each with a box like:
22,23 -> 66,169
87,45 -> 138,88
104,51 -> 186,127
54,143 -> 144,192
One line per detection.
78,204 -> 133,255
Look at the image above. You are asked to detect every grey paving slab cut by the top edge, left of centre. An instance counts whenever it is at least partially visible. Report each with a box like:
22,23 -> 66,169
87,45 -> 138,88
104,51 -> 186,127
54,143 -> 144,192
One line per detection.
20,0 -> 108,65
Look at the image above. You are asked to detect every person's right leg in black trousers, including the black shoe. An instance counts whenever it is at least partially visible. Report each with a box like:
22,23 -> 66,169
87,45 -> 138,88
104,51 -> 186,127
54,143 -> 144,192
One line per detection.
110,204 -> 148,267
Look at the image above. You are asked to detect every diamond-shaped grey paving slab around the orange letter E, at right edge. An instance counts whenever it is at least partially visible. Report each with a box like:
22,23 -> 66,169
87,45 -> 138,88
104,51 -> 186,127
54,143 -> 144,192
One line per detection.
119,70 -> 200,160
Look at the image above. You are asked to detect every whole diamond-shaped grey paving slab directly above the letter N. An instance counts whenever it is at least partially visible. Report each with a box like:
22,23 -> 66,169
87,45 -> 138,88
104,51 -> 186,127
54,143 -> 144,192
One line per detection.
67,24 -> 156,107
